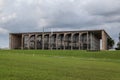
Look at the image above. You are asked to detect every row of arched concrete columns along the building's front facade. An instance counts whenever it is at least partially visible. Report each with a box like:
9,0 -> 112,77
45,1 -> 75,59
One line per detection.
21,32 -> 89,50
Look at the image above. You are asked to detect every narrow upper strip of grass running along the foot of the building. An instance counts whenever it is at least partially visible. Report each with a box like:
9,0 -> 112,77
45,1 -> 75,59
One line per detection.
0,50 -> 120,59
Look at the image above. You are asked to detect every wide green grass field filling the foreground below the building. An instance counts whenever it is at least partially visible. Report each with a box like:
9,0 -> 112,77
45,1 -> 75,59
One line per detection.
0,50 -> 120,80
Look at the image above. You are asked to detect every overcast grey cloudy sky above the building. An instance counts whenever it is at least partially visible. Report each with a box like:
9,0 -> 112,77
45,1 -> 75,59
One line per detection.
0,0 -> 120,48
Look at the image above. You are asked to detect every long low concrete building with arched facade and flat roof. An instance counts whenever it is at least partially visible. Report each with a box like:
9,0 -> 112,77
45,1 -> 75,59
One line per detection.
9,30 -> 110,50
